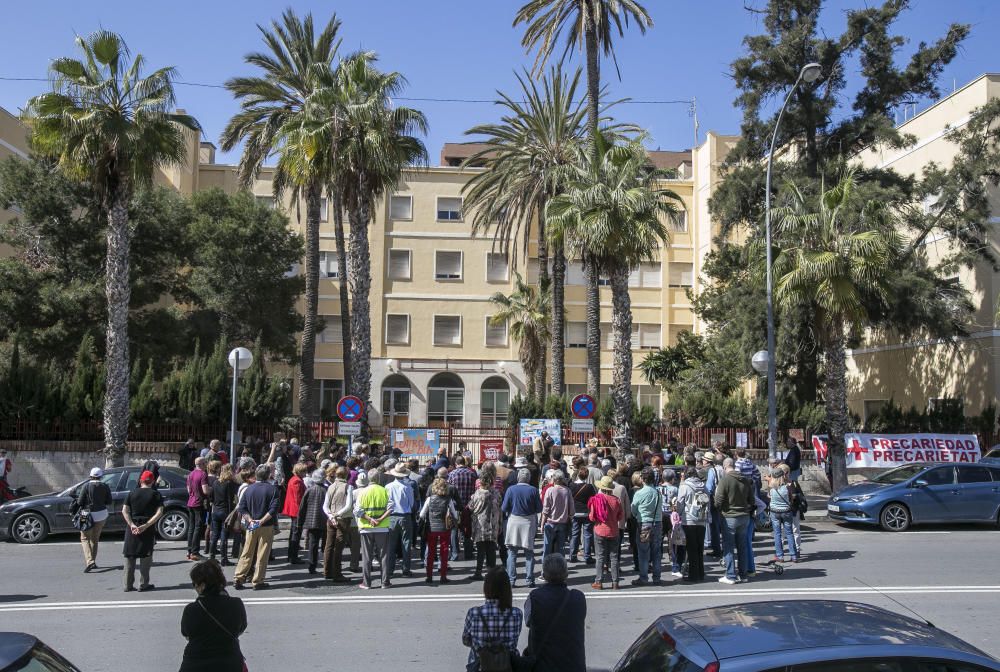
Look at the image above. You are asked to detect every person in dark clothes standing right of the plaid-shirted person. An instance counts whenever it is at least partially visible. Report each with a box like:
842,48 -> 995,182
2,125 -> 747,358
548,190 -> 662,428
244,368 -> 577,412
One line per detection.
524,553 -> 587,672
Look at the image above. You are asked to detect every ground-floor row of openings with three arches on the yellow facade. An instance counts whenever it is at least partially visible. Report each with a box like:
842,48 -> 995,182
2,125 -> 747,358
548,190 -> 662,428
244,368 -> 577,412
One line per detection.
315,372 -> 661,427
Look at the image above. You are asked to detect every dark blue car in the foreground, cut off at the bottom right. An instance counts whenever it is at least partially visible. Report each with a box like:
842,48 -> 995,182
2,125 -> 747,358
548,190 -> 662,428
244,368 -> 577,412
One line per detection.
614,600 -> 1000,672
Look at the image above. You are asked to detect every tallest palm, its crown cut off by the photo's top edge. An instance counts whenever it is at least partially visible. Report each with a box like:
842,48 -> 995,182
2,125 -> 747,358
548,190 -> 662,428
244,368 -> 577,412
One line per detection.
514,0 -> 653,399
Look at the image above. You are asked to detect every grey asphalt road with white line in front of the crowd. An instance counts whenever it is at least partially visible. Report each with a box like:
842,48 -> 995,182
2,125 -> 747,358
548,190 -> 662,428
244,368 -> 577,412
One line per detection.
0,519 -> 1000,672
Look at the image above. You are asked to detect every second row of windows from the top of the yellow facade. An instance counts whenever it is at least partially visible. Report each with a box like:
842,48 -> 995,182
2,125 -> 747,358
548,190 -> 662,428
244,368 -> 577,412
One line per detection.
319,249 -> 694,288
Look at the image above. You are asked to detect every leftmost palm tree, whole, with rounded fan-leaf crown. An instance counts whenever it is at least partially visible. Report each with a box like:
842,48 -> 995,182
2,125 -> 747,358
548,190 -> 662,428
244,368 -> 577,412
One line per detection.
24,31 -> 200,466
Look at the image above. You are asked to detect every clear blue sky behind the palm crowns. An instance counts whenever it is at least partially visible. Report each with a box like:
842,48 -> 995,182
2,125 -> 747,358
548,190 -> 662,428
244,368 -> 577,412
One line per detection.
0,0 -> 1000,164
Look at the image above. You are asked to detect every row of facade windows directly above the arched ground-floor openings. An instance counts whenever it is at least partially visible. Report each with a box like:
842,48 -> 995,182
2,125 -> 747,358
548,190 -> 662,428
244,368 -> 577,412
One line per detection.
317,313 -> 663,350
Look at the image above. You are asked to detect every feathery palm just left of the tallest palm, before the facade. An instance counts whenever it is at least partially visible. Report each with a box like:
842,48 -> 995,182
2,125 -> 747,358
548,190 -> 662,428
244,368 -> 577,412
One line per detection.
462,68 -> 586,395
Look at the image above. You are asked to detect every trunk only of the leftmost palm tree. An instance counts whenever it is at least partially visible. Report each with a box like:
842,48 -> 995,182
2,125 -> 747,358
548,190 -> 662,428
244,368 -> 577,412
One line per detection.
104,190 -> 132,467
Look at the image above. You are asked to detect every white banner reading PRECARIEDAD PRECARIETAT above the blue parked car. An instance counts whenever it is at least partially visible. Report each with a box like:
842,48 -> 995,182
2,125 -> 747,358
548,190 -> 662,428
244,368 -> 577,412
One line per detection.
844,434 -> 979,469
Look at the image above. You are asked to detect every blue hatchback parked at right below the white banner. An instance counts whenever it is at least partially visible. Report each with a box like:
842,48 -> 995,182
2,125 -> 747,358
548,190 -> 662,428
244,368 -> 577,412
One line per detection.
826,463 -> 1000,532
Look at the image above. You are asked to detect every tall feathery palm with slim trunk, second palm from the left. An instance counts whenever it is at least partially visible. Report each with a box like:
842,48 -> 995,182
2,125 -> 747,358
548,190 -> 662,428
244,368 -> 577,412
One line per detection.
221,9 -> 343,420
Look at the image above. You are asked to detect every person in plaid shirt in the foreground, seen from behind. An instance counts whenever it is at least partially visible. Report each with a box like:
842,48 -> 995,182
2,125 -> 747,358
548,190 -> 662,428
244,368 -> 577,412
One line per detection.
462,568 -> 524,672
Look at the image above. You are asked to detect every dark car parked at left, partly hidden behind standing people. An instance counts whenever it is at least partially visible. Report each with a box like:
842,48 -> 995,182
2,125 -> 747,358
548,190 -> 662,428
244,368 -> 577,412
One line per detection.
0,466 -> 188,544
